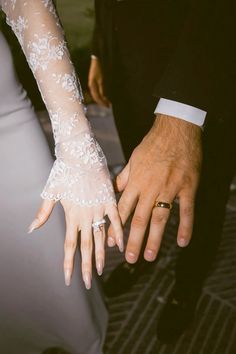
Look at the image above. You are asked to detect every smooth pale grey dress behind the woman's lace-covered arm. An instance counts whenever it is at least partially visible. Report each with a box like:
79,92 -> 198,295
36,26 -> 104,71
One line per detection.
0,33 -> 107,354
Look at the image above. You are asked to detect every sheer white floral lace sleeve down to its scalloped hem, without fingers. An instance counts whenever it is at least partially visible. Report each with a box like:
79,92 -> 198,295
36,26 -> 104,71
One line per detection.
0,0 -> 115,206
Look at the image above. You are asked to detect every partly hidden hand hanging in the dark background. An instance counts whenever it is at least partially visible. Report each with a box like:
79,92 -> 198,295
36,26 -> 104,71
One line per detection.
88,58 -> 111,107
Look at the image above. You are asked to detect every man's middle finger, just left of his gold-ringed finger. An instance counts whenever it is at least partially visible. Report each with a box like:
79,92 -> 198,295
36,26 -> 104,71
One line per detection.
125,195 -> 154,263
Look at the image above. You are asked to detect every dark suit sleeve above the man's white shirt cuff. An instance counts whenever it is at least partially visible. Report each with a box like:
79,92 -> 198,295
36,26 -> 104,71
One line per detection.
154,0 -> 230,116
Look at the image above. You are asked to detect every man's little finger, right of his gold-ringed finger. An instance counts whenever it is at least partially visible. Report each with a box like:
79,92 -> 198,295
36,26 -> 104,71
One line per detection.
177,193 -> 194,247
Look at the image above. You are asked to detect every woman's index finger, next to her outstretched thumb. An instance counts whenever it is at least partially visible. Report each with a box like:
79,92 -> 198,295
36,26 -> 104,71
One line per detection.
64,220 -> 78,286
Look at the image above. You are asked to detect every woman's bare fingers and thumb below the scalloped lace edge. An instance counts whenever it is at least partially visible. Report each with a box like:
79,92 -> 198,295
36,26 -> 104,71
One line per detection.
29,194 -> 123,289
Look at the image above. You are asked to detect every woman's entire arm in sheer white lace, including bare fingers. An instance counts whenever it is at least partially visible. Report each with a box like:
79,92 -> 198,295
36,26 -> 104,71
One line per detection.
0,0 -> 123,288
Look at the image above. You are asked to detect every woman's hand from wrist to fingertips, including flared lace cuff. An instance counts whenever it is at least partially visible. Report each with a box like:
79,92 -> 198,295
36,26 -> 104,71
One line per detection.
29,130 -> 123,289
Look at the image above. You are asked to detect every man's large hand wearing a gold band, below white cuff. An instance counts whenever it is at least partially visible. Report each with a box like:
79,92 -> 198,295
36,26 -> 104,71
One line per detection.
108,115 -> 202,263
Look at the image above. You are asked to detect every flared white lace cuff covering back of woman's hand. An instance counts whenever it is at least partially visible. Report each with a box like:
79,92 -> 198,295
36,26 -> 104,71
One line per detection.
42,132 -> 115,206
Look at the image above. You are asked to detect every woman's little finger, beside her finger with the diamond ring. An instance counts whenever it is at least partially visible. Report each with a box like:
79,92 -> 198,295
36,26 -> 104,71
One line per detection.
107,206 -> 124,252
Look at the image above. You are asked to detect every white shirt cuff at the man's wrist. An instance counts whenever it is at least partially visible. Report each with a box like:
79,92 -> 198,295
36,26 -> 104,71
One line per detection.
154,98 -> 207,127
